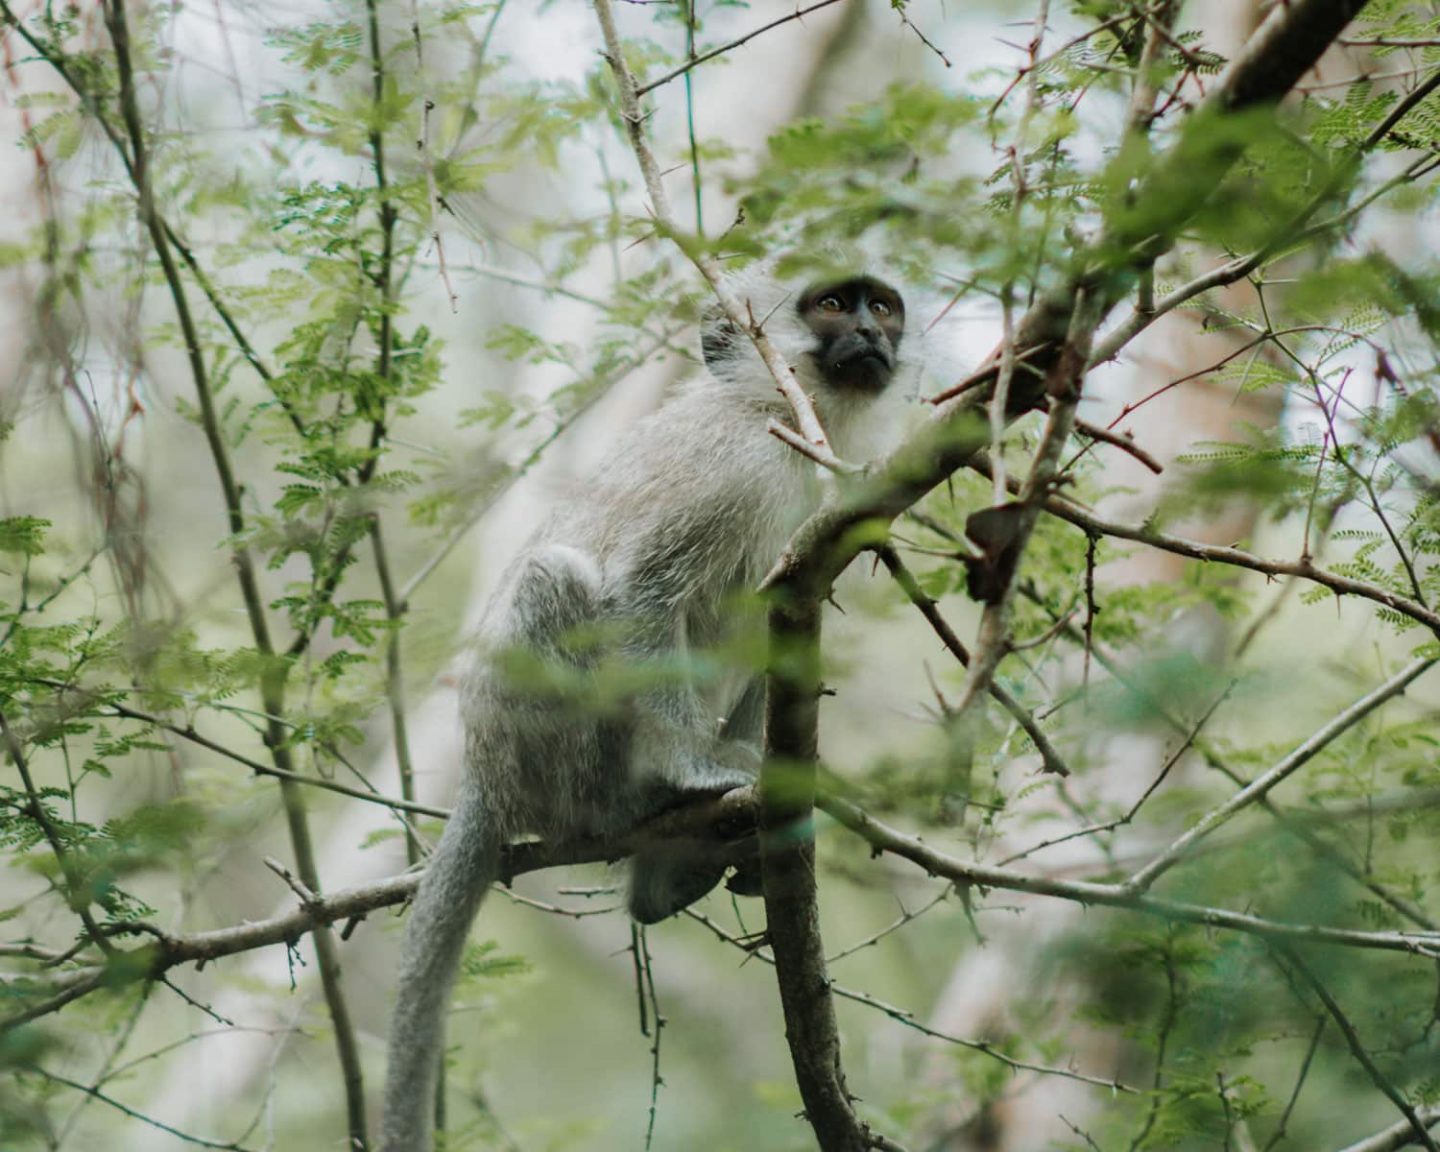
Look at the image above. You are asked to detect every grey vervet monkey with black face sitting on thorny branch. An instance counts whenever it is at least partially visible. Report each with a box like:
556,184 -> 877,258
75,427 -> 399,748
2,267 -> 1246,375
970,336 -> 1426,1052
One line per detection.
383,274 -> 904,1152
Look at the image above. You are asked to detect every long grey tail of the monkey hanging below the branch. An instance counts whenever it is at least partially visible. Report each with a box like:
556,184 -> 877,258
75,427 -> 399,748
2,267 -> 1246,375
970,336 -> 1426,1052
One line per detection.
380,779 -> 501,1152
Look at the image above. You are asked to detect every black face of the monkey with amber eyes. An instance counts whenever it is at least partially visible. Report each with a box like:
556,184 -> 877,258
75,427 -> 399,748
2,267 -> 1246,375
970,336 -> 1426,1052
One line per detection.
799,276 -> 904,393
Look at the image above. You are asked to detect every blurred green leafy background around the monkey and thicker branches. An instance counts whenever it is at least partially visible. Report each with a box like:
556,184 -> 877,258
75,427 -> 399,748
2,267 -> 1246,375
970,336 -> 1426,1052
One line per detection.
0,0 -> 1440,1152
